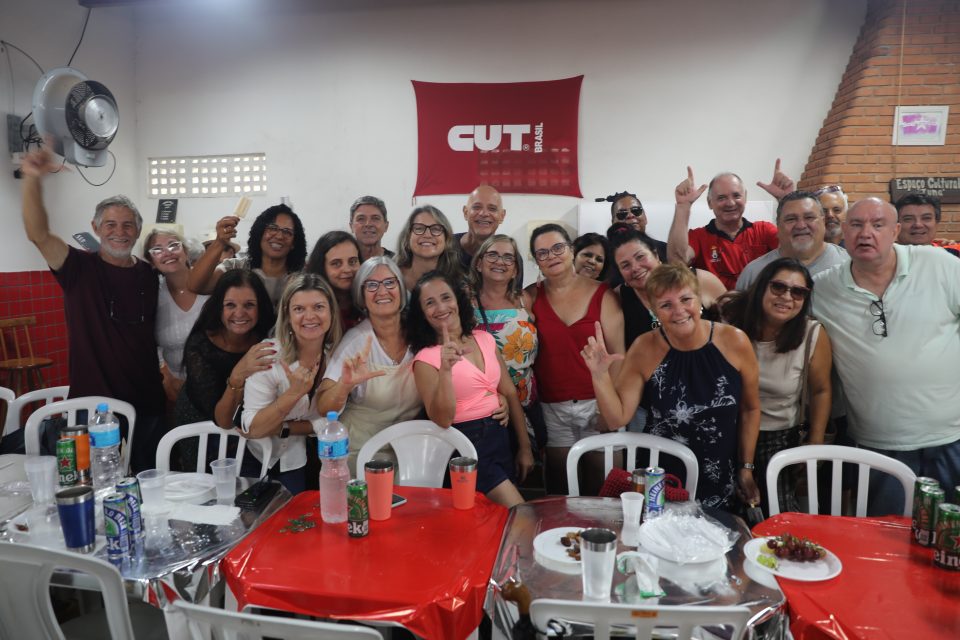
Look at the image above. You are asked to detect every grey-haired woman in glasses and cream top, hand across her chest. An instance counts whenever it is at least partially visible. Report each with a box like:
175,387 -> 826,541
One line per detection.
317,256 -> 423,475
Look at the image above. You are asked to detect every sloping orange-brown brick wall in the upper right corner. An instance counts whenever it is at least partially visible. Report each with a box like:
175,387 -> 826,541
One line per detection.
798,0 -> 960,239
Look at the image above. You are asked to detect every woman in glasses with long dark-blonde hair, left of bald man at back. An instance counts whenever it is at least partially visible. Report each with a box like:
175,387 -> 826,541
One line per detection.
397,204 -> 461,291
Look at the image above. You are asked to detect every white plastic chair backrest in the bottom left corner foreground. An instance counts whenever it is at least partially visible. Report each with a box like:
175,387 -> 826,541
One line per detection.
0,542 -> 134,640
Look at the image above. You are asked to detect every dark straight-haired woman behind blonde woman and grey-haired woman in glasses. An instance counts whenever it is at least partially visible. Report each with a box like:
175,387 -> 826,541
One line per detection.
304,231 -> 363,331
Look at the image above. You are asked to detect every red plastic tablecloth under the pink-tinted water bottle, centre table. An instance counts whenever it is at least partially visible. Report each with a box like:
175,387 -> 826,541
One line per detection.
221,487 -> 507,639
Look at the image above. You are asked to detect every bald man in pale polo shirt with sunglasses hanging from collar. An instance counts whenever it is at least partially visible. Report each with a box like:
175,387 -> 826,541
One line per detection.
813,198 -> 960,515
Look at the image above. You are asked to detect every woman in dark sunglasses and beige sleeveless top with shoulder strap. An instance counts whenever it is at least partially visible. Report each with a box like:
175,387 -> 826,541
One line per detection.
724,258 -> 833,512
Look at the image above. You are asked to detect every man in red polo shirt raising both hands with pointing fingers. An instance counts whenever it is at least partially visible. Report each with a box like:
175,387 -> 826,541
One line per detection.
667,159 -> 794,289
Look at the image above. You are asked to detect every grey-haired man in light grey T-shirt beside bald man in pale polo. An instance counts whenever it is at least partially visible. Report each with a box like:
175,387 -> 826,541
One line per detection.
737,191 -> 847,291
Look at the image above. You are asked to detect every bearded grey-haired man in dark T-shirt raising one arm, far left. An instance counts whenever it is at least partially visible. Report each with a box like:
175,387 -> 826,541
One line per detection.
22,149 -> 164,472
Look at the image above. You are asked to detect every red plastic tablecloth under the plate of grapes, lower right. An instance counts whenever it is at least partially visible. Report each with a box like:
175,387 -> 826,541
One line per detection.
753,513 -> 960,640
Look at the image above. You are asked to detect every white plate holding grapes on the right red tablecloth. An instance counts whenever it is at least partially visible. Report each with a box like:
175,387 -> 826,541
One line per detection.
743,533 -> 843,582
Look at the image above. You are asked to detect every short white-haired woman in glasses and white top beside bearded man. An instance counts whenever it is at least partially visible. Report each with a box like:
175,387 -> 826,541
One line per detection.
143,228 -> 209,403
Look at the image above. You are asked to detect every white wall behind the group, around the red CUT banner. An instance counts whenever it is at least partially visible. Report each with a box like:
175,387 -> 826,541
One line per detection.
0,0 -> 866,273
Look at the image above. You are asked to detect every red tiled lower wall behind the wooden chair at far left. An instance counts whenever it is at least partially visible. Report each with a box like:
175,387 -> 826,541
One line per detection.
0,271 -> 70,387
